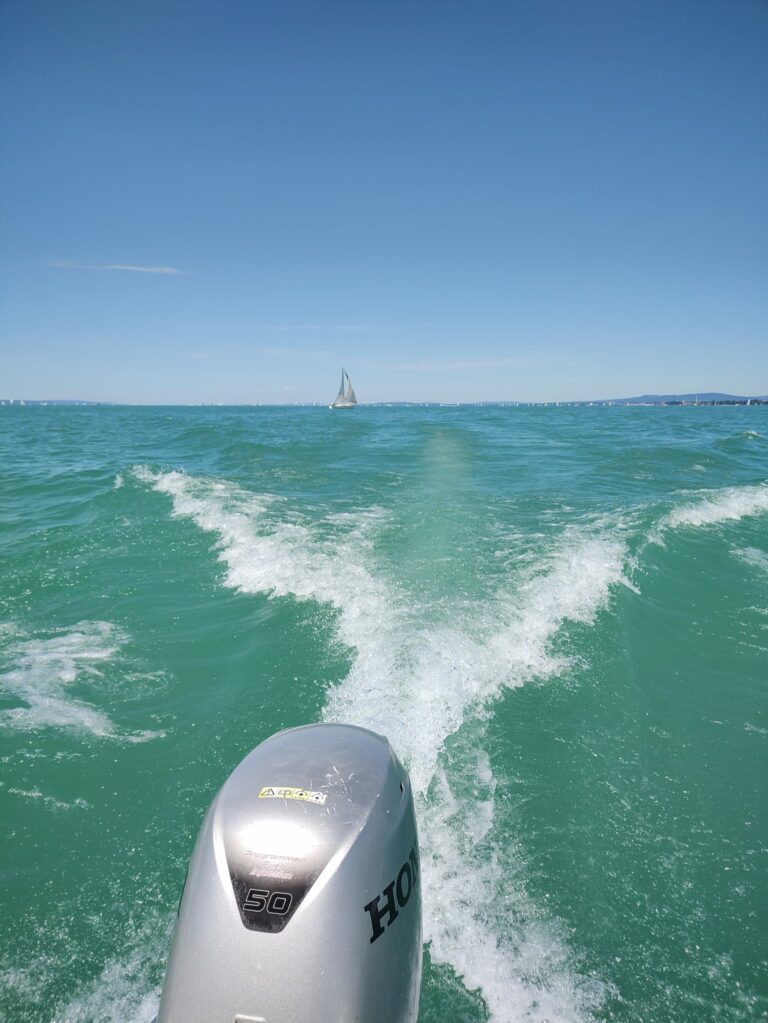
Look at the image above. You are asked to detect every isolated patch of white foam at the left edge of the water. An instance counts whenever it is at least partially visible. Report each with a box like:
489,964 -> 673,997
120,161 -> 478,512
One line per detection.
0,622 -> 157,742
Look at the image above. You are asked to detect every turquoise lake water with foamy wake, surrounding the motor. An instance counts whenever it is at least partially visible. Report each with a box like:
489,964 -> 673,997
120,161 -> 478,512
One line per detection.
0,406 -> 768,1023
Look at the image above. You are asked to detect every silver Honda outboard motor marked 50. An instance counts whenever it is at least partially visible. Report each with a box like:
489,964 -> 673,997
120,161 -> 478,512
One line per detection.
156,724 -> 421,1023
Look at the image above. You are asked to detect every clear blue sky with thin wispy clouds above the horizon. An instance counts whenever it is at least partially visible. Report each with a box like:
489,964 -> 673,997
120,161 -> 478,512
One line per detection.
0,0 -> 768,403
